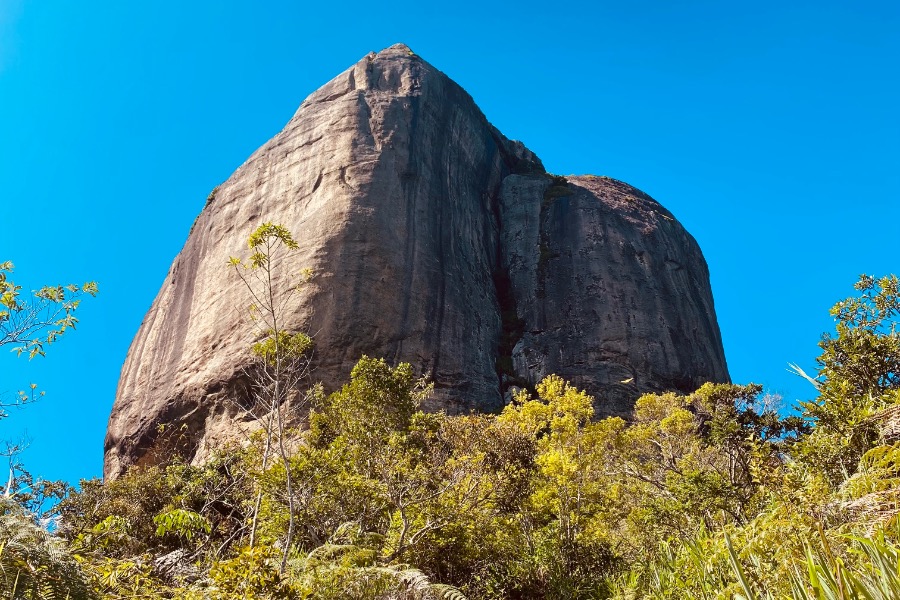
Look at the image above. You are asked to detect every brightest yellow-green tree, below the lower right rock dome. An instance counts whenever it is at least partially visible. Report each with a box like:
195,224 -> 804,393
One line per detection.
498,375 -> 624,598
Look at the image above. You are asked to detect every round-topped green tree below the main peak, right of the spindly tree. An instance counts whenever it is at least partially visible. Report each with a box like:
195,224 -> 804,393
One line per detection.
310,356 -> 486,563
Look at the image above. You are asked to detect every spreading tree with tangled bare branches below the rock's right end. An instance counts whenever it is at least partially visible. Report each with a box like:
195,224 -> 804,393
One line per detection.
611,383 -> 799,538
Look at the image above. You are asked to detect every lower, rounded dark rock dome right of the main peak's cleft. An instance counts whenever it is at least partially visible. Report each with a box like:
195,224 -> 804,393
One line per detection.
500,175 -> 728,416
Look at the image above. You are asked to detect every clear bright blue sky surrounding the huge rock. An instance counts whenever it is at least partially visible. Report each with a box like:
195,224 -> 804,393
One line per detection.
0,0 -> 900,481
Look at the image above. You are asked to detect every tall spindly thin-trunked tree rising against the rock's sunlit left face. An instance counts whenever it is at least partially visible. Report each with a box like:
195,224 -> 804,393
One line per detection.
229,222 -> 313,571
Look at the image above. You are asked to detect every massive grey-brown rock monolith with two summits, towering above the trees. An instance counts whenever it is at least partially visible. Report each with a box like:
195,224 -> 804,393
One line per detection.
104,44 -> 728,477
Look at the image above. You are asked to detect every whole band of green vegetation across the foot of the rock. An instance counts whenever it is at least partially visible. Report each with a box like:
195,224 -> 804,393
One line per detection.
0,234 -> 900,599
